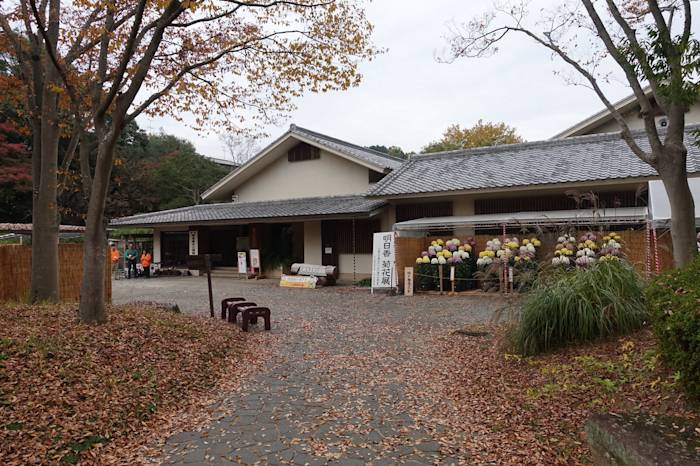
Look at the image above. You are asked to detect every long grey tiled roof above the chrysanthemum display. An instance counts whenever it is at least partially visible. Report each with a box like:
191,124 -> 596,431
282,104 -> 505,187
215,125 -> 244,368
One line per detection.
368,125 -> 700,197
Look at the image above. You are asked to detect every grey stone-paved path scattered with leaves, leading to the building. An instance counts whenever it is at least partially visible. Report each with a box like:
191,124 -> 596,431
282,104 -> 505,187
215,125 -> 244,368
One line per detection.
113,277 -> 503,465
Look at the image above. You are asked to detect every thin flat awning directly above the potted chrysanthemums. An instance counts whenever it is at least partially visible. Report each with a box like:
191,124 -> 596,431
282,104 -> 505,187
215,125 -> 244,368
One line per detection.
394,207 -> 648,231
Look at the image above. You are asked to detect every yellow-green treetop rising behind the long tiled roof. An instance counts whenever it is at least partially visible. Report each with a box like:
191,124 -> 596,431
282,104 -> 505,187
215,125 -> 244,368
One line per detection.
423,120 -> 524,153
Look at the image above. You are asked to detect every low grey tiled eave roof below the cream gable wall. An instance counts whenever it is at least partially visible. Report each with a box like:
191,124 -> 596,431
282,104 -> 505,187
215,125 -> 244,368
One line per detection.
110,196 -> 392,226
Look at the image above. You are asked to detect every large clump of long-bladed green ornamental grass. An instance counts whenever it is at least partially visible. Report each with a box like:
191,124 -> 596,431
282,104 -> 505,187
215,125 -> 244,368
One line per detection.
511,261 -> 648,355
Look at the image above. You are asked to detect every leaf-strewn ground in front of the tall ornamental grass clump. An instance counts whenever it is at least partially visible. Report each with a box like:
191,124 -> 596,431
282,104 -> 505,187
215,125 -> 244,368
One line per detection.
406,327 -> 700,464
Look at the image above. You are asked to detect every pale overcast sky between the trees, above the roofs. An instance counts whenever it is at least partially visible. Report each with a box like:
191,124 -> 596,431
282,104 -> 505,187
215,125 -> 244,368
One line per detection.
135,0 -> 697,157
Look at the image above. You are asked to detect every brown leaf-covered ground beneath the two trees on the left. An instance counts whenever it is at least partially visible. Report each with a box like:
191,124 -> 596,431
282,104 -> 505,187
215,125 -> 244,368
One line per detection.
0,305 -> 266,464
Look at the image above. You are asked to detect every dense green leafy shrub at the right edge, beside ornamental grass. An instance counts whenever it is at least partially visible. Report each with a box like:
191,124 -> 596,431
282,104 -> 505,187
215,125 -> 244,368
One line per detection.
647,253 -> 700,400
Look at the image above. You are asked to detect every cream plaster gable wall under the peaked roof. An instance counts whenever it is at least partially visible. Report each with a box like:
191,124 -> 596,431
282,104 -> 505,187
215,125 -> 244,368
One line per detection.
235,150 -> 369,202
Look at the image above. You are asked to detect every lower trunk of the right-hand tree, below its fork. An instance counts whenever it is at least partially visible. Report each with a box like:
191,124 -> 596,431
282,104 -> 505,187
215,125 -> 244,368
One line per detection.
658,148 -> 697,267
